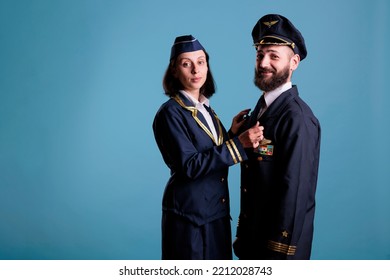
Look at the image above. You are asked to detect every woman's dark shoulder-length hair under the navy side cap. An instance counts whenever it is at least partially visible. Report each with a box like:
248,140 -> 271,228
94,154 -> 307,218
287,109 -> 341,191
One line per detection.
163,52 -> 216,98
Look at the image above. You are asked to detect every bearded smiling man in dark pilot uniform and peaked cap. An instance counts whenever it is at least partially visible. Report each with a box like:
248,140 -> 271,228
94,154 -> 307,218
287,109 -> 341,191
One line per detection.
233,14 -> 321,259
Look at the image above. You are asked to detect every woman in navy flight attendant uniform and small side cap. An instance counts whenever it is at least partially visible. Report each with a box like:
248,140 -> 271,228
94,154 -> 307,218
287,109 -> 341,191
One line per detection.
153,35 -> 262,260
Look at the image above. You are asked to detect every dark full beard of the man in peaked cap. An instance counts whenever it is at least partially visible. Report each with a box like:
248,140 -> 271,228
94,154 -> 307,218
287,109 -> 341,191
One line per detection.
253,66 -> 290,92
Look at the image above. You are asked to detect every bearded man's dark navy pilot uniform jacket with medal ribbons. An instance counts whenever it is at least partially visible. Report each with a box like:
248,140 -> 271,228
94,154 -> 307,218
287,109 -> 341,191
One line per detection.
233,86 -> 321,259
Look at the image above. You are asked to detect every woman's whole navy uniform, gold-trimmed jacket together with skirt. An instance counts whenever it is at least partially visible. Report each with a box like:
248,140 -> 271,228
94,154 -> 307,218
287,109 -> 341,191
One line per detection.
153,95 -> 247,259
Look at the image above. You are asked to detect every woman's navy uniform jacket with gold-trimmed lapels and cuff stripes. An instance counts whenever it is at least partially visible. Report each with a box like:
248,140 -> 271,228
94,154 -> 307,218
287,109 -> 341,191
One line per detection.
153,94 -> 247,225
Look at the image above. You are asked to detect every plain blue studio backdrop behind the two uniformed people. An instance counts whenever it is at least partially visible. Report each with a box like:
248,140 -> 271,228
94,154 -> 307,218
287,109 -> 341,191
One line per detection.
0,0 -> 390,260
